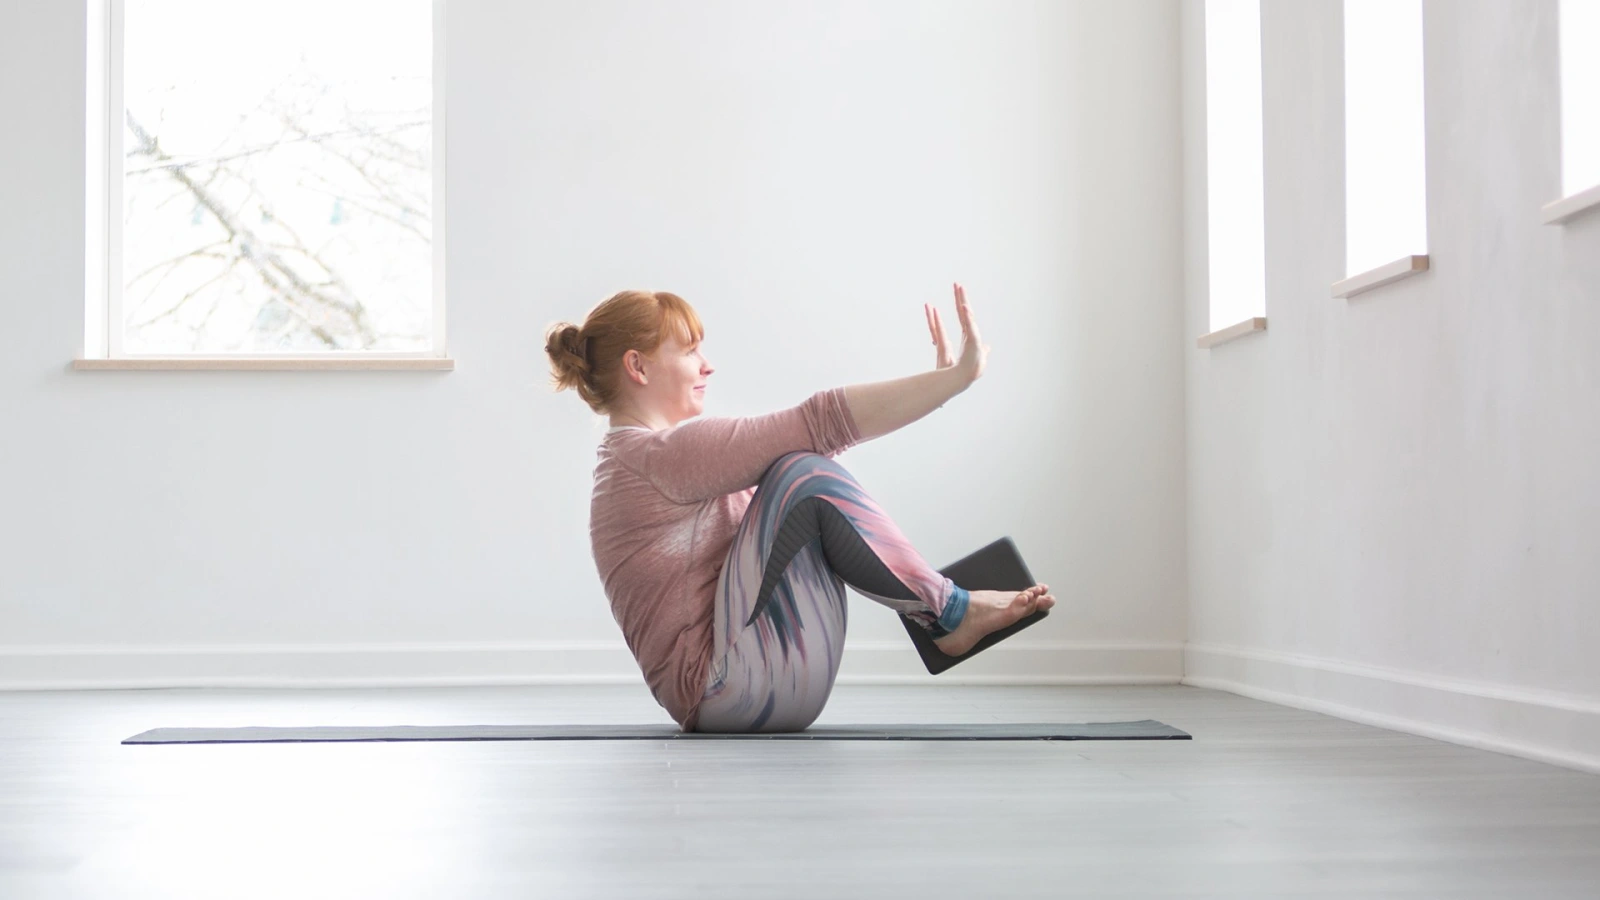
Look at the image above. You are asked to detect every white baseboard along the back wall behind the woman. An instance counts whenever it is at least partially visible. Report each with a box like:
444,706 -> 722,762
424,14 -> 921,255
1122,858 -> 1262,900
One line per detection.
0,641 -> 1184,690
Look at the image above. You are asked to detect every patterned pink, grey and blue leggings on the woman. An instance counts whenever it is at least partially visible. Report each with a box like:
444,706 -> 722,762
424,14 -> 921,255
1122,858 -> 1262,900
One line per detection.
694,453 -> 968,732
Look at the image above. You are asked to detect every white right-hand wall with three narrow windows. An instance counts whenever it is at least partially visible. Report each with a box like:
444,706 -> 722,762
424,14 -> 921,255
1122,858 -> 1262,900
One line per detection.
1182,0 -> 1600,769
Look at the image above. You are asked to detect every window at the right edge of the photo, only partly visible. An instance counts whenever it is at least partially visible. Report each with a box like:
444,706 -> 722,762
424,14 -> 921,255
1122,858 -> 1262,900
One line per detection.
1544,0 -> 1600,224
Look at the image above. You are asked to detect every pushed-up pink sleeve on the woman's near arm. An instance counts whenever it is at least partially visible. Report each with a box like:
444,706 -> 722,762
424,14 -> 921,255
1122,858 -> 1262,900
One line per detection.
622,388 -> 861,503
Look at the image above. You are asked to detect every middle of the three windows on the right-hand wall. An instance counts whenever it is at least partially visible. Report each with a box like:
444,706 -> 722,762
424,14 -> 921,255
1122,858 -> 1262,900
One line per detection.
1334,0 -> 1427,296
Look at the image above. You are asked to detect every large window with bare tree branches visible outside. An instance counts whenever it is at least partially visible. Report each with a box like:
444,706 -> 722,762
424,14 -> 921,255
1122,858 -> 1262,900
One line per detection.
85,0 -> 445,359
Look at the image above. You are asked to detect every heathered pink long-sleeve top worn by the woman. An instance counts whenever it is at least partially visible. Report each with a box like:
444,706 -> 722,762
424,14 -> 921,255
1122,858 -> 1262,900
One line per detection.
589,388 -> 861,732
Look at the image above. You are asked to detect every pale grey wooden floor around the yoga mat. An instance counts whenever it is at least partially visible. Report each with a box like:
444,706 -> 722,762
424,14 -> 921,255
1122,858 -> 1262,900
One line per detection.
0,685 -> 1600,900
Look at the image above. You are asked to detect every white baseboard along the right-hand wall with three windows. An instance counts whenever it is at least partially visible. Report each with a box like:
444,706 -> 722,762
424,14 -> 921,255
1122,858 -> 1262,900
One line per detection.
1182,642 -> 1600,773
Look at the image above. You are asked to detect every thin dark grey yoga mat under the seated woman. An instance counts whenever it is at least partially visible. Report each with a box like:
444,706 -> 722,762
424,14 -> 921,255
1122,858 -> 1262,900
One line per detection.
122,719 -> 1190,743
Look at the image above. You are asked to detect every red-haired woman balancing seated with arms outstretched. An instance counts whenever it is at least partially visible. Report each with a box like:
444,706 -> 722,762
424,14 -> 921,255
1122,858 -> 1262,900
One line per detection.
544,285 -> 1056,732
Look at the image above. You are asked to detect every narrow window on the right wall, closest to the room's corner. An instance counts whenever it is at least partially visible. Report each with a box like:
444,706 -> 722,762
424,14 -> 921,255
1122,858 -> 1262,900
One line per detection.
1200,0 -> 1267,348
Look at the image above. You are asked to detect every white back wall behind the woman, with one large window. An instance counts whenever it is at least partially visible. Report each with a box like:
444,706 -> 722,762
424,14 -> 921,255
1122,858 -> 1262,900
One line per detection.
0,0 -> 1187,690
